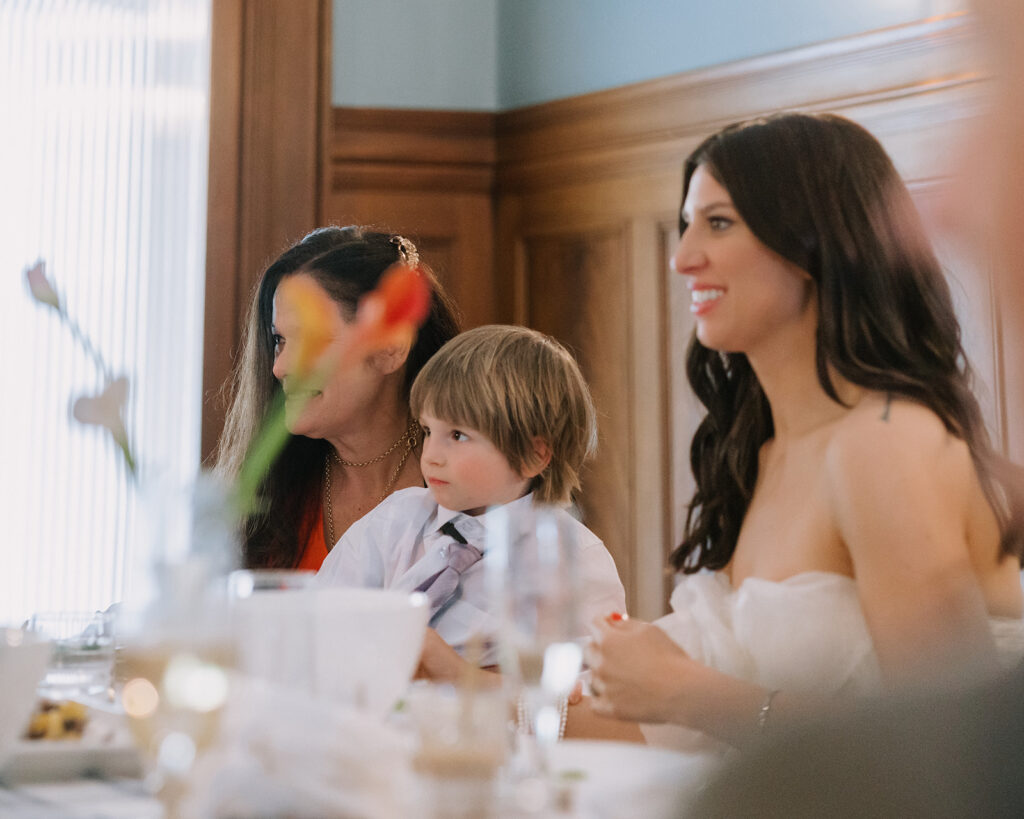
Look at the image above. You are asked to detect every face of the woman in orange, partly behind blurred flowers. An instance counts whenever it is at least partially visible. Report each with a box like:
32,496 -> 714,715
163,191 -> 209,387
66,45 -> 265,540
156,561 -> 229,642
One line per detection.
271,273 -> 384,438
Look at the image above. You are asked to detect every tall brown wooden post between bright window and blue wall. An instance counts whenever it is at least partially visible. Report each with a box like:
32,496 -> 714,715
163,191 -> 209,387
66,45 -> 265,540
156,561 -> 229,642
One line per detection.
202,0 -> 331,458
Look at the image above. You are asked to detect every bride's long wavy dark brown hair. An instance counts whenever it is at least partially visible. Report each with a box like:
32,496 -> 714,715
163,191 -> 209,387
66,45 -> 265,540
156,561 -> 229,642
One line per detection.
672,114 -> 1024,572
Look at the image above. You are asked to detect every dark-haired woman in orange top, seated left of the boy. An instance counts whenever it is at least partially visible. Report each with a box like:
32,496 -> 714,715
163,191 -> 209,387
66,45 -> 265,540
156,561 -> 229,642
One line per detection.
217,226 -> 459,570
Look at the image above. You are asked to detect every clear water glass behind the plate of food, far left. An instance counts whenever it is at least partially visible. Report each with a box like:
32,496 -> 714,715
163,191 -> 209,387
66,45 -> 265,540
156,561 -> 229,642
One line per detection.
26,611 -> 115,700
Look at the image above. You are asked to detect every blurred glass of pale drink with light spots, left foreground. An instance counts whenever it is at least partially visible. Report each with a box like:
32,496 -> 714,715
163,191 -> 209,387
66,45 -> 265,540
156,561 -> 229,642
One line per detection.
116,476 -> 238,819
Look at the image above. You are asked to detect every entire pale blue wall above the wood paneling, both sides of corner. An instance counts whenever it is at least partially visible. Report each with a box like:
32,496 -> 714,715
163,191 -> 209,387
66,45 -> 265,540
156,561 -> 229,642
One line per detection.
333,0 -> 966,111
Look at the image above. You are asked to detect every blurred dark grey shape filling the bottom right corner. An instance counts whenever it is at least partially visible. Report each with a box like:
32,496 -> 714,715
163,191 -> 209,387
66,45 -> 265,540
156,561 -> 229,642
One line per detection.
687,670 -> 1024,819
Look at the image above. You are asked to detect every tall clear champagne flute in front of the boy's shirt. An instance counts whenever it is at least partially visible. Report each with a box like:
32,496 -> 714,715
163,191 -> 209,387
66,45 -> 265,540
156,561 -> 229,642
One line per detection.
487,504 -> 586,803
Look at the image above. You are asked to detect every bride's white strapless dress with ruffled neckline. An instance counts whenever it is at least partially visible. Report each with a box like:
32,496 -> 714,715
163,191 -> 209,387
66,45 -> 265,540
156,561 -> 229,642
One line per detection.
642,571 -> 1024,758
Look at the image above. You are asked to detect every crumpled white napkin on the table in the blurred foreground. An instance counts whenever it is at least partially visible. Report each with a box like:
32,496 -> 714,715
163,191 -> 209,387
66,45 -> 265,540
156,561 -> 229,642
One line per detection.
182,676 -> 415,819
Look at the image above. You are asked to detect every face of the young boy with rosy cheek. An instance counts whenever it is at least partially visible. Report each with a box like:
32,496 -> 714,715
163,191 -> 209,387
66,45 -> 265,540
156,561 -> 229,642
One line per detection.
420,413 -> 532,515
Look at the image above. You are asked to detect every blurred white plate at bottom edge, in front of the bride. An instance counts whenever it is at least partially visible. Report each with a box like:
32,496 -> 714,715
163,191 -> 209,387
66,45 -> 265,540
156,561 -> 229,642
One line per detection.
549,739 -> 710,819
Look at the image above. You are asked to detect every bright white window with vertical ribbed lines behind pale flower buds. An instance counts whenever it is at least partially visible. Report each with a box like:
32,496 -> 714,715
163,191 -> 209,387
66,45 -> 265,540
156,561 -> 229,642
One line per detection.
0,0 -> 211,622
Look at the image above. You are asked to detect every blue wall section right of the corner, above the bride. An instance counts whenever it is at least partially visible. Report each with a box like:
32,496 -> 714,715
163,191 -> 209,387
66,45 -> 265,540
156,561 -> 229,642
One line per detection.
498,0 -> 965,110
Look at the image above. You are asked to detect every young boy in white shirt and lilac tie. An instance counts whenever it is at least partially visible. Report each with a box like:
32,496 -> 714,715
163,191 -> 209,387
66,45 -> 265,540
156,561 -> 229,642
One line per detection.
318,326 -> 626,665
